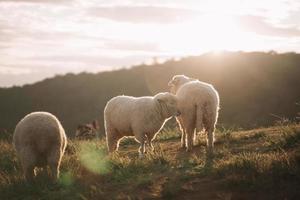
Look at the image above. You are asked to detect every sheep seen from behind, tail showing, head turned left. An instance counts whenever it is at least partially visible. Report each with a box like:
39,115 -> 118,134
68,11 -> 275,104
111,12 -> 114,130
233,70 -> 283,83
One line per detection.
168,75 -> 220,154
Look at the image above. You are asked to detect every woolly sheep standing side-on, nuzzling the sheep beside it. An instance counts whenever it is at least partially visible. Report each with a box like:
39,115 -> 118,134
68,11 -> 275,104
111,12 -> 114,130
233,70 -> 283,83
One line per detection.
104,92 -> 180,157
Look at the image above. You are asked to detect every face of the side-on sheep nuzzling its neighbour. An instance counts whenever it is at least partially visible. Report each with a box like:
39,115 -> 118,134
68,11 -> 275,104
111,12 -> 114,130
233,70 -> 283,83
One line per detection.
156,92 -> 181,118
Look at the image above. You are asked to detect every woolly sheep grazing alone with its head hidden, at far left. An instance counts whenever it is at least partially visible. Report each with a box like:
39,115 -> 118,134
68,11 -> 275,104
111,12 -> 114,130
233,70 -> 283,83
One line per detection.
13,112 -> 67,182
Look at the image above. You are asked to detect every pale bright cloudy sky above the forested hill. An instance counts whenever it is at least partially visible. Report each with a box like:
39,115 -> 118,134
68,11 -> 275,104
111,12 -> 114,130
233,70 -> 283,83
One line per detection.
0,0 -> 300,87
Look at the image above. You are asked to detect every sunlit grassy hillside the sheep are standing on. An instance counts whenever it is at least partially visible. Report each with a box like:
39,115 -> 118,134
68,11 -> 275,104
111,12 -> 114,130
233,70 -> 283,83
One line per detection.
0,124 -> 300,200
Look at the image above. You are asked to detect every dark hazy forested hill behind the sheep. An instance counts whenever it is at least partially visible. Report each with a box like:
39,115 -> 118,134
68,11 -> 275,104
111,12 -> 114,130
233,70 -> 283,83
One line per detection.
0,52 -> 300,136
